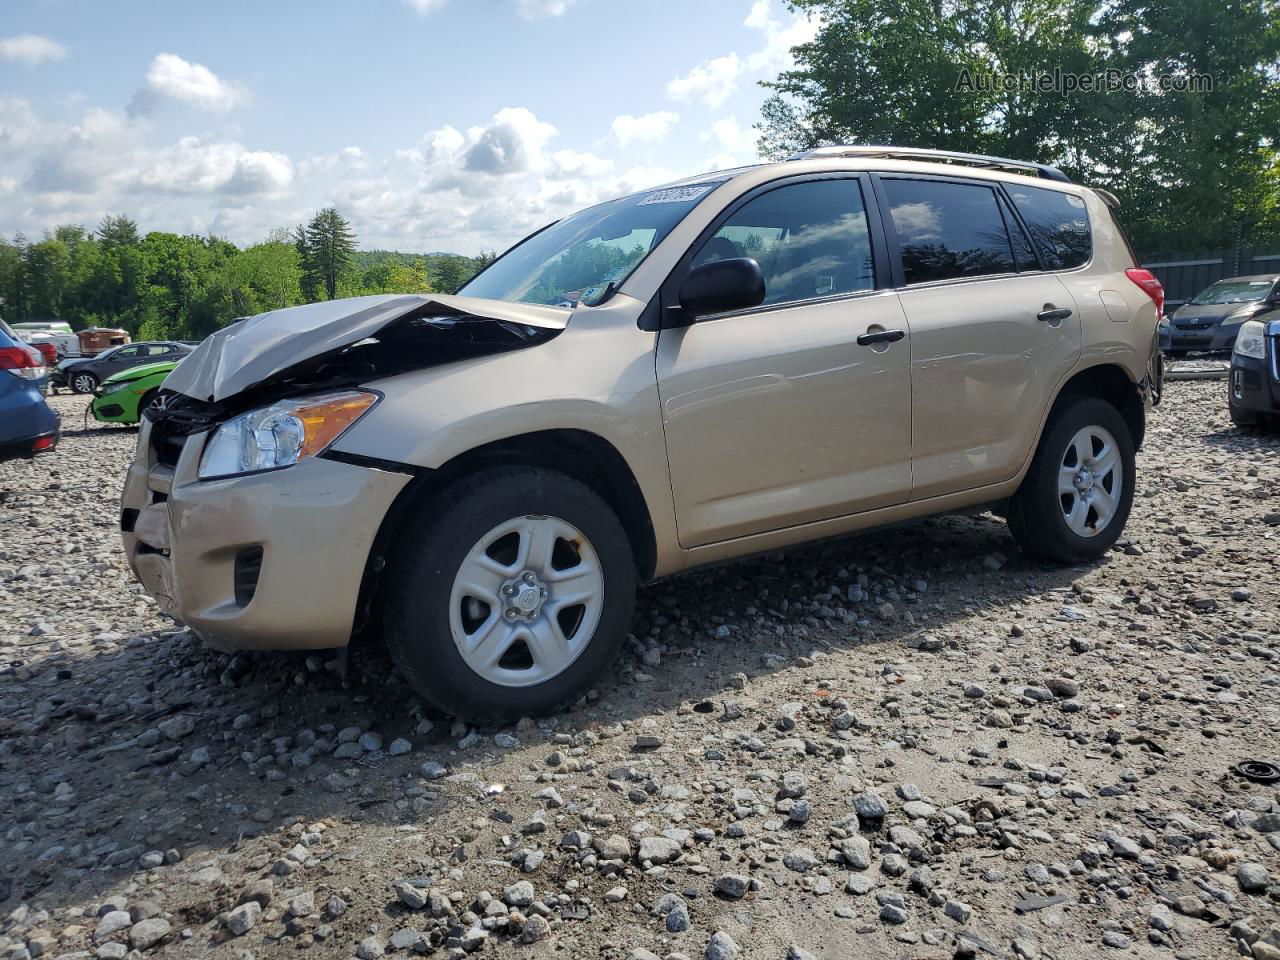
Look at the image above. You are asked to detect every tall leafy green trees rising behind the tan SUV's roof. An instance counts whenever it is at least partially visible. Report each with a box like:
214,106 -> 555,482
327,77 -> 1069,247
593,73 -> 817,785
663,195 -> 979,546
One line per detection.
760,0 -> 1280,253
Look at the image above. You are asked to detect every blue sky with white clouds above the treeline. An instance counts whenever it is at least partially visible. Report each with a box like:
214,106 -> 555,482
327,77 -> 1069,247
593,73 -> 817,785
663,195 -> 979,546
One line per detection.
0,0 -> 815,255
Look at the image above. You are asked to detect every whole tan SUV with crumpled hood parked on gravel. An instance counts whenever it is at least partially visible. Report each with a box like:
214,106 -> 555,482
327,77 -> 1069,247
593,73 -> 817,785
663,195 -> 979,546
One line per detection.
122,147 -> 1162,719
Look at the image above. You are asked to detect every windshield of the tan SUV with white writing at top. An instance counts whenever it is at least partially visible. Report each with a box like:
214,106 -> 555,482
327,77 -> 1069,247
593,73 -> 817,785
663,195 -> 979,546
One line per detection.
458,180 -> 723,307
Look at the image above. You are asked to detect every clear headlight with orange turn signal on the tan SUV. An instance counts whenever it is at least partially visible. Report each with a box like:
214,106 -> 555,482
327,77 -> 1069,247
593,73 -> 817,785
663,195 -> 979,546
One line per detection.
200,390 -> 379,480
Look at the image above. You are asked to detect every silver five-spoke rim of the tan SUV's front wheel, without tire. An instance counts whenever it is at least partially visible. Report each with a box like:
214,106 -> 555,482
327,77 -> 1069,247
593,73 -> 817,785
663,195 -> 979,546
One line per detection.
449,515 -> 604,687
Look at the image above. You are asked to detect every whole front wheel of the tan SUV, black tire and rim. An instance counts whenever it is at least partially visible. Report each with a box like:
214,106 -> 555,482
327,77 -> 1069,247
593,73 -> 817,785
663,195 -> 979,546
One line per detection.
383,467 -> 636,723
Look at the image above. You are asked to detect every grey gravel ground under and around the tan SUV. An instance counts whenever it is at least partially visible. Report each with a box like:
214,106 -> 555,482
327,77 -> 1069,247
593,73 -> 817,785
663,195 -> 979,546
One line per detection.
0,381 -> 1280,960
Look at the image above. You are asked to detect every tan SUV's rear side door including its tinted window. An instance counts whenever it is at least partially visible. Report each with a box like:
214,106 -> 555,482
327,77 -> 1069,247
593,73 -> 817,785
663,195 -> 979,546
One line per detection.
876,174 -> 1080,499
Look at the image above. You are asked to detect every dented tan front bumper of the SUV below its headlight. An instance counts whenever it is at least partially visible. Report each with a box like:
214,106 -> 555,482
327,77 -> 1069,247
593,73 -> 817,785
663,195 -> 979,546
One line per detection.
122,420 -> 410,650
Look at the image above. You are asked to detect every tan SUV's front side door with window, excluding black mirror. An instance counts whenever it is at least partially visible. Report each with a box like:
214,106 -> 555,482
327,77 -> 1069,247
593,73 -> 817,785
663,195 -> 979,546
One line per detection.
657,175 -> 911,547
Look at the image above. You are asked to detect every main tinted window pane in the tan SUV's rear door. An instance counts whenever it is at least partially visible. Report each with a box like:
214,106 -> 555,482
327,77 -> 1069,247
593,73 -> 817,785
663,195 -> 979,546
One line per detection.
881,178 -> 1014,284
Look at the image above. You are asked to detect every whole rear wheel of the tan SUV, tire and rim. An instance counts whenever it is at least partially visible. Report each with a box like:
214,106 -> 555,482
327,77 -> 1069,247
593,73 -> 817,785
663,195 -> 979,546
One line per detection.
1009,397 -> 1135,563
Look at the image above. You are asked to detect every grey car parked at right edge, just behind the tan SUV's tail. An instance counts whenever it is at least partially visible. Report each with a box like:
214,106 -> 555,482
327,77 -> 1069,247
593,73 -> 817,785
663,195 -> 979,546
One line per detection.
1160,274 -> 1280,357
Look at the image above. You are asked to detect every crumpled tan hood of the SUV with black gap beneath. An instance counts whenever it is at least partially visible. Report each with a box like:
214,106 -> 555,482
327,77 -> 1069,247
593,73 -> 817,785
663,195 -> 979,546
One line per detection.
158,294 -> 570,413
